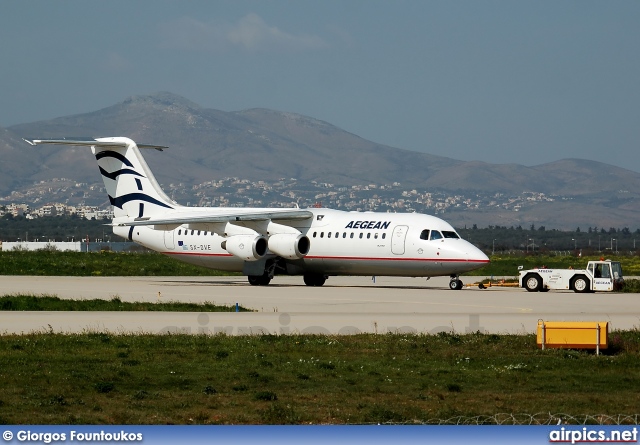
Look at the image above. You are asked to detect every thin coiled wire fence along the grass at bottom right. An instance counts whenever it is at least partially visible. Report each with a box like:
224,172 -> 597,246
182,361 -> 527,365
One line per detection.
381,413 -> 640,425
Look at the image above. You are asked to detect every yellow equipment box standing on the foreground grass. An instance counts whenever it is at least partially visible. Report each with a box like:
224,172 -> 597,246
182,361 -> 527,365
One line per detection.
537,320 -> 609,350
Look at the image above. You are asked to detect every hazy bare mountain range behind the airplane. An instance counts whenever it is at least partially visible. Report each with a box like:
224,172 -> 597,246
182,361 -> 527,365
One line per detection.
0,92 -> 640,229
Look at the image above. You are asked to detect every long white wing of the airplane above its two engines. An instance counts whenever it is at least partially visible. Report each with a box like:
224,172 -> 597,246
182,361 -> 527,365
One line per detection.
114,209 -> 313,226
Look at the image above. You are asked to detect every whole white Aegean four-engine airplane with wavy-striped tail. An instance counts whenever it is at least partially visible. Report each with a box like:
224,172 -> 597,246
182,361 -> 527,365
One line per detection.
25,137 -> 489,290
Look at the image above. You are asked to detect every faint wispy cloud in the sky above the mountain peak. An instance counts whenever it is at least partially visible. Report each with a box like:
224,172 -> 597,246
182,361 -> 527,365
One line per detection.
161,13 -> 328,52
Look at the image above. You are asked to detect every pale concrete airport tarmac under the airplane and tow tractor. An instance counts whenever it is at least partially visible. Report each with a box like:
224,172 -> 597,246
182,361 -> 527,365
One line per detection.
0,276 -> 640,335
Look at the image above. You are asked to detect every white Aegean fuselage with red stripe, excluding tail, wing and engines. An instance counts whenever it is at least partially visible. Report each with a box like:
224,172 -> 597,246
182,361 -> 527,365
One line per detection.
119,208 -> 489,277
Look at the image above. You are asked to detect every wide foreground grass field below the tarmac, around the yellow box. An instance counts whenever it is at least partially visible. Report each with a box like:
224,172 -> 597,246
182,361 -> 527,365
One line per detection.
0,331 -> 640,424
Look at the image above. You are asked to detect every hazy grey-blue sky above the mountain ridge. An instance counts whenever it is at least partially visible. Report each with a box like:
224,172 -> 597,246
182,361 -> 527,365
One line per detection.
0,0 -> 640,172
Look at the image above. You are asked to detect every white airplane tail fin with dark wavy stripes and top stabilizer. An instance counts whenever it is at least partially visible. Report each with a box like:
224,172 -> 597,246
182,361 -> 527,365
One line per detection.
25,137 -> 180,218
